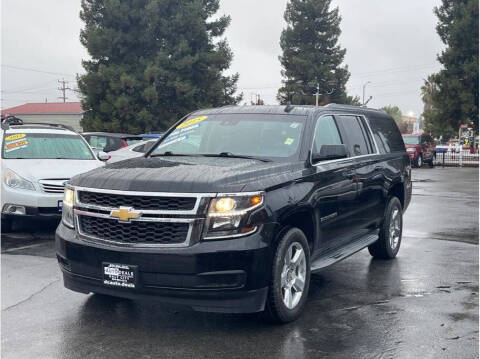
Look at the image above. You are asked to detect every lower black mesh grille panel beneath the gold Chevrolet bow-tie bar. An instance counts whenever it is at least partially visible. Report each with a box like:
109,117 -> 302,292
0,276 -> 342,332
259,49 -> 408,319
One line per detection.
78,216 -> 189,244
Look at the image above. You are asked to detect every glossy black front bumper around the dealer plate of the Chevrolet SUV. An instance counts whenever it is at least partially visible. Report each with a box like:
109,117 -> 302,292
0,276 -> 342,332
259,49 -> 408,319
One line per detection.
55,223 -> 274,313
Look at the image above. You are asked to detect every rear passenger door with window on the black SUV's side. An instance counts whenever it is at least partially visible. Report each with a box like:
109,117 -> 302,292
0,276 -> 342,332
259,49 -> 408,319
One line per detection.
335,115 -> 385,235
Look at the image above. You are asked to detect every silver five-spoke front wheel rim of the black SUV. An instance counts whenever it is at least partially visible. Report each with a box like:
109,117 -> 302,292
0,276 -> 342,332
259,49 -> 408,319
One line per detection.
280,242 -> 307,309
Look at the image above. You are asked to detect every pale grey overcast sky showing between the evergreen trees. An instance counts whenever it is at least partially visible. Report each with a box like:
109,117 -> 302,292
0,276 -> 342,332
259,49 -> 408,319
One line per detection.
1,0 -> 443,115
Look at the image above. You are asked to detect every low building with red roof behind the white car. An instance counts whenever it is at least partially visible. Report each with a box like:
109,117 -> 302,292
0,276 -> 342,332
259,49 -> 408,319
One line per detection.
2,102 -> 85,131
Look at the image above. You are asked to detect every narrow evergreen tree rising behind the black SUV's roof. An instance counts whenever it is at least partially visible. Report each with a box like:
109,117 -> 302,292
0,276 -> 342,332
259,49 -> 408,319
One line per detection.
277,0 -> 352,105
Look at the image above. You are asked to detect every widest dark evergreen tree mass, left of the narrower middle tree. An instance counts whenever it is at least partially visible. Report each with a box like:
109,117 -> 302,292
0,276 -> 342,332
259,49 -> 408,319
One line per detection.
78,0 -> 241,133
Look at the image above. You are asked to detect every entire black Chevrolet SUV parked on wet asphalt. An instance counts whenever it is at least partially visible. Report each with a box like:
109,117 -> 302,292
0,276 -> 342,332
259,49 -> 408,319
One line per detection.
56,104 -> 412,322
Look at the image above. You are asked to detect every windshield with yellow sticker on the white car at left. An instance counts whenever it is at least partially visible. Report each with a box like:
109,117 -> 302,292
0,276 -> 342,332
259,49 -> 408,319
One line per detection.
2,133 -> 94,160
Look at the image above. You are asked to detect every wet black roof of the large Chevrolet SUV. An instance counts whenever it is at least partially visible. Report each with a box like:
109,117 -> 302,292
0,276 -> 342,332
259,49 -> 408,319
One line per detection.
192,103 -> 384,116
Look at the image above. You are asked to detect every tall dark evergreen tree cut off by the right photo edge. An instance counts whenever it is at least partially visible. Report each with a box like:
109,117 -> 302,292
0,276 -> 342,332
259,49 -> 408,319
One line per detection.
422,0 -> 479,135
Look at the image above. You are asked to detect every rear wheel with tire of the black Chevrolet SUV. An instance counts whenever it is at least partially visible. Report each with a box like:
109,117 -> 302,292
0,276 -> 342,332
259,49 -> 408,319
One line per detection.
368,197 -> 403,259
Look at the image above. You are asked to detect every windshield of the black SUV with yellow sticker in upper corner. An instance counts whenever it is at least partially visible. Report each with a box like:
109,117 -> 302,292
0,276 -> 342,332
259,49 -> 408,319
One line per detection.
151,114 -> 304,159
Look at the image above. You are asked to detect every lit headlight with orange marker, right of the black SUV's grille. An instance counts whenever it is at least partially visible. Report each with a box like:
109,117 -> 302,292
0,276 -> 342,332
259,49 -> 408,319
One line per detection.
204,193 -> 264,240
